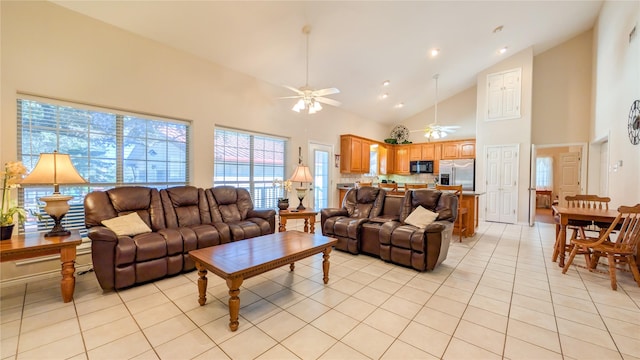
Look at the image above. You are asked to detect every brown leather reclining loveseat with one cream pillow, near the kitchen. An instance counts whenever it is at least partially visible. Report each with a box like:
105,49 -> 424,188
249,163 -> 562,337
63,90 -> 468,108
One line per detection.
320,187 -> 458,271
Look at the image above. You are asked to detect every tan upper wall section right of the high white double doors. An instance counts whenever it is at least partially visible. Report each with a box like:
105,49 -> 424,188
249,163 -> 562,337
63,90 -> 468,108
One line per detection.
531,30 -> 593,145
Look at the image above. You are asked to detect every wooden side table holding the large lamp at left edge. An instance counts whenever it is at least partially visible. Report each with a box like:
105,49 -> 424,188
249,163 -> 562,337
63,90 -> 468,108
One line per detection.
0,230 -> 82,302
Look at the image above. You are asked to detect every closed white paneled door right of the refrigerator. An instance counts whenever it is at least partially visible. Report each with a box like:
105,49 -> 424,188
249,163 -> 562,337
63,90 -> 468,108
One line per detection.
485,145 -> 519,224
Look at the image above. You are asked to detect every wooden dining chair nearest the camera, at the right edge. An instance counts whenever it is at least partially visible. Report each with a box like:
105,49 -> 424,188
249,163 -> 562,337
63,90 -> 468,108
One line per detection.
562,204 -> 640,290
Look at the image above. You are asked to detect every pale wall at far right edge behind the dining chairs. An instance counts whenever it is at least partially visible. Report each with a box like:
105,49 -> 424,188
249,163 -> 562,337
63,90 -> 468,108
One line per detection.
589,1 -> 640,207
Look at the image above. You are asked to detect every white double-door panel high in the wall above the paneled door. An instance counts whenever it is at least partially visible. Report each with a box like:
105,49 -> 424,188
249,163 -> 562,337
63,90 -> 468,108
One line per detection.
487,68 -> 522,121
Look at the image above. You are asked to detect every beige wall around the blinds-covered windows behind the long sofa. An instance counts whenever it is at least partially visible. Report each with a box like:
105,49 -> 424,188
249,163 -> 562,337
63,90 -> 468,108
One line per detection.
0,1 -> 389,279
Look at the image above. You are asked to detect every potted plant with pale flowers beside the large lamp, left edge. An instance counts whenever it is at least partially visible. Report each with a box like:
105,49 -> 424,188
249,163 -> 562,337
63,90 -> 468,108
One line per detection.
0,161 -> 27,240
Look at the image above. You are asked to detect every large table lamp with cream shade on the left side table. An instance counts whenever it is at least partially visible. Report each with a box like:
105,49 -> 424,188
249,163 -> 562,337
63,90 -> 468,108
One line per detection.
22,151 -> 87,237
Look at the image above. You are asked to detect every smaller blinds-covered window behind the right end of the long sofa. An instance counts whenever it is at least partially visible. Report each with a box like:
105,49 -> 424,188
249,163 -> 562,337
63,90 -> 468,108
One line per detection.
213,128 -> 287,208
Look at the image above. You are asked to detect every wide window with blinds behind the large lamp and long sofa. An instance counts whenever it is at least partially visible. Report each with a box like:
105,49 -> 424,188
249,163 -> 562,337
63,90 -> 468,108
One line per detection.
18,97 -> 189,234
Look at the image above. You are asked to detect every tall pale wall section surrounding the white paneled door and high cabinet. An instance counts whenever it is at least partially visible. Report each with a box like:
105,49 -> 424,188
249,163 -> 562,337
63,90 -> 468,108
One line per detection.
476,48 -> 533,223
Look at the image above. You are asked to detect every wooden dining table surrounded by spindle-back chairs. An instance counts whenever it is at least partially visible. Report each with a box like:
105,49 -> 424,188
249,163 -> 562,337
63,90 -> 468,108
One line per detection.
552,205 -> 618,267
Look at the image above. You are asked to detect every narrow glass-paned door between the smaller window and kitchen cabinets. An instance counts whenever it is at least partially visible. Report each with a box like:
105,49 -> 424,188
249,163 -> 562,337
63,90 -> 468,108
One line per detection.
309,143 -> 333,210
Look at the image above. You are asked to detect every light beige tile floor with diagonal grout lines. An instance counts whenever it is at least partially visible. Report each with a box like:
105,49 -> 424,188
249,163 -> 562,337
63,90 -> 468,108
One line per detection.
0,219 -> 640,359
